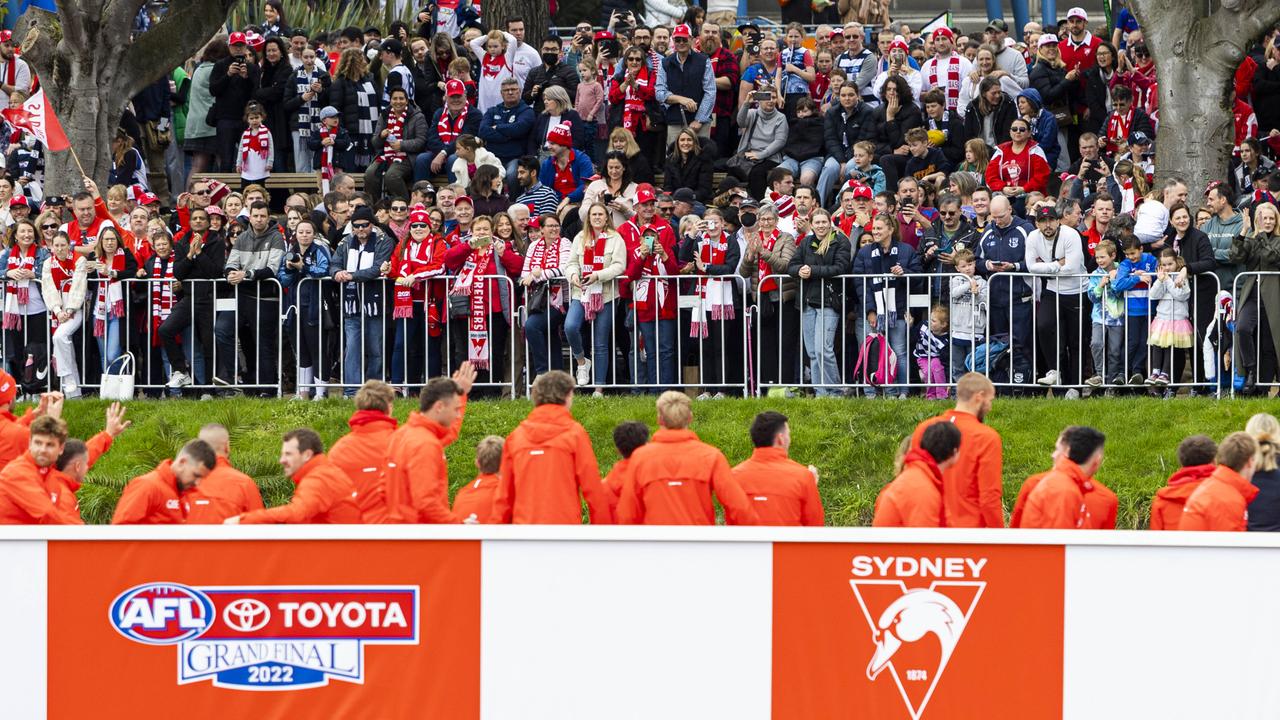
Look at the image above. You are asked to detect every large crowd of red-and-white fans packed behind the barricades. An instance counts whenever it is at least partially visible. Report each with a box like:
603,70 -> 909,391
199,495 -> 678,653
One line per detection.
0,0 -> 1280,398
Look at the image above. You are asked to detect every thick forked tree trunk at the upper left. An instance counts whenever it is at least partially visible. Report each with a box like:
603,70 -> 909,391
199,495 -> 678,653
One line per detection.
18,0 -> 232,195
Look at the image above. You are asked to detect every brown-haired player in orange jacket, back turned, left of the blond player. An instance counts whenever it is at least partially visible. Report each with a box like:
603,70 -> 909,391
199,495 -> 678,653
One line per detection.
493,370 -> 613,525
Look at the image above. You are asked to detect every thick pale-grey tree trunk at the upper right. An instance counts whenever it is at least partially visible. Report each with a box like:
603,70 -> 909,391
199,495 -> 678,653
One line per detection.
1130,0 -> 1280,202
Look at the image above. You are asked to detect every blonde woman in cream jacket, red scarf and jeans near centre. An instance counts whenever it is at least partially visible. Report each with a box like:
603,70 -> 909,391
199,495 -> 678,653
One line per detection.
564,202 -> 627,396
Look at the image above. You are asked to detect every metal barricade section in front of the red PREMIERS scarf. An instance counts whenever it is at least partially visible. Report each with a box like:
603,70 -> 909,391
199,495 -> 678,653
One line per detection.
293,275 -> 520,400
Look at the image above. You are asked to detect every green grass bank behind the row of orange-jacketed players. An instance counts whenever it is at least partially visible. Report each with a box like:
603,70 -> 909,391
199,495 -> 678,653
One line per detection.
47,397 -> 1276,528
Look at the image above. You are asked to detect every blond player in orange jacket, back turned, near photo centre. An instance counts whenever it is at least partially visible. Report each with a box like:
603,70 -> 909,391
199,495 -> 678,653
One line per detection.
617,391 -> 758,525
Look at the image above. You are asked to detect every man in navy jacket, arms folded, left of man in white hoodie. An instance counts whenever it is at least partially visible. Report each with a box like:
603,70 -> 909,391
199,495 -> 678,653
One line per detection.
974,193 -> 1036,384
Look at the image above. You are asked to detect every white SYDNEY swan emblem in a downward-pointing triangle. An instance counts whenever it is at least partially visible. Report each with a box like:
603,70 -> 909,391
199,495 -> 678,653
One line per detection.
849,555 -> 987,720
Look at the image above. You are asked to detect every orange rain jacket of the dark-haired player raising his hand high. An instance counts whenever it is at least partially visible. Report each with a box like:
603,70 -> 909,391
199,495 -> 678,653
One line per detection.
387,396 -> 466,523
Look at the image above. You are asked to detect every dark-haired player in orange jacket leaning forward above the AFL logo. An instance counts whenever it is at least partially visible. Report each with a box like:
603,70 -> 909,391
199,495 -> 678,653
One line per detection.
111,439 -> 218,525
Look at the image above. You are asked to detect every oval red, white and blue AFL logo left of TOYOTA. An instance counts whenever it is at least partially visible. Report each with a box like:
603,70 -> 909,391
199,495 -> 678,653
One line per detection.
111,583 -> 214,644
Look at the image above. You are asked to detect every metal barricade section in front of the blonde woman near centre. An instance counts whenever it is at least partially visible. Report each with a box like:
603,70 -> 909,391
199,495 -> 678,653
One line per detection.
521,274 -> 754,396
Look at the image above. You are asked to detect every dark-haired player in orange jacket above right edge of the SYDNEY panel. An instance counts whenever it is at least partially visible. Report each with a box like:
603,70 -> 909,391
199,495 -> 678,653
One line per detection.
1021,425 -> 1106,529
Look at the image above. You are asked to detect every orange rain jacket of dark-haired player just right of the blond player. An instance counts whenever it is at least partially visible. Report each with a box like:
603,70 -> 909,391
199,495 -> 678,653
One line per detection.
733,447 -> 824,527
